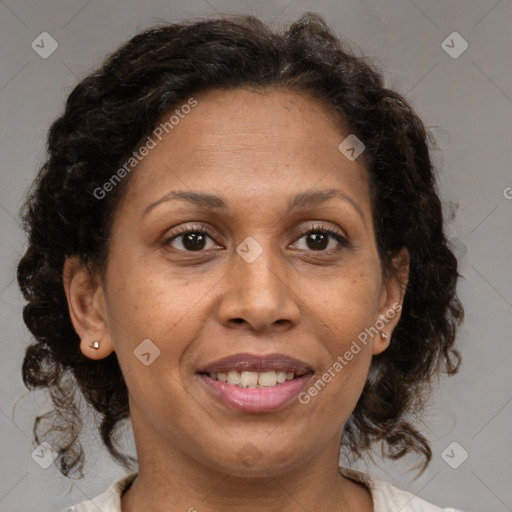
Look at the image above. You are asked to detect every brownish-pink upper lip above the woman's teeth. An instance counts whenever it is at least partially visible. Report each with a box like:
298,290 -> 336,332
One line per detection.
199,354 -> 312,375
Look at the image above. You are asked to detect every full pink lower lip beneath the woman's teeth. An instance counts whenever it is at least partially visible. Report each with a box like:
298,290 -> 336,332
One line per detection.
199,373 -> 313,412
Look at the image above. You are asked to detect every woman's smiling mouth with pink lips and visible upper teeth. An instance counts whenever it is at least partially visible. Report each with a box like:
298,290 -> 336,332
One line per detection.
197,354 -> 314,413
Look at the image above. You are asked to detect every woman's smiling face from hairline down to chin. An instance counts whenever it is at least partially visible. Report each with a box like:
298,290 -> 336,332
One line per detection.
66,89 -> 408,476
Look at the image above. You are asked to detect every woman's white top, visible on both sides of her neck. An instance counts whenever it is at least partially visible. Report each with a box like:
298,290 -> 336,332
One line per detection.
65,467 -> 462,512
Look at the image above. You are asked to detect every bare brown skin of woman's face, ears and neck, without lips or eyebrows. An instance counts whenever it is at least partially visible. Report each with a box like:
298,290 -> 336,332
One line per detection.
64,89 -> 408,512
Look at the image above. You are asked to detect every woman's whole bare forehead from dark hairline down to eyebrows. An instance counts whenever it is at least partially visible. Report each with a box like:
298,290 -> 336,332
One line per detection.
117,85 -> 368,218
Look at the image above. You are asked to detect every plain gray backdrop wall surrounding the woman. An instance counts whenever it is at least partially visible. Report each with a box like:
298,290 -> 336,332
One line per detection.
0,0 -> 512,512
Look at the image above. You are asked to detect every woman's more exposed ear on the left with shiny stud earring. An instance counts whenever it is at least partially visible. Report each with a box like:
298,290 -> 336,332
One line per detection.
63,256 -> 114,359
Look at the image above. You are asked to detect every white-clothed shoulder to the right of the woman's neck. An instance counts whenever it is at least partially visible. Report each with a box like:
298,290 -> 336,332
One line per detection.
339,466 -> 462,512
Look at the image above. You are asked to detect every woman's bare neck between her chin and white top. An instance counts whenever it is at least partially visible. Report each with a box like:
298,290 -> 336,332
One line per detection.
122,410 -> 372,512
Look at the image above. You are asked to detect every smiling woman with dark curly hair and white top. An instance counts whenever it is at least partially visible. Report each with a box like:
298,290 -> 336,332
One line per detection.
18,10 -> 463,512
